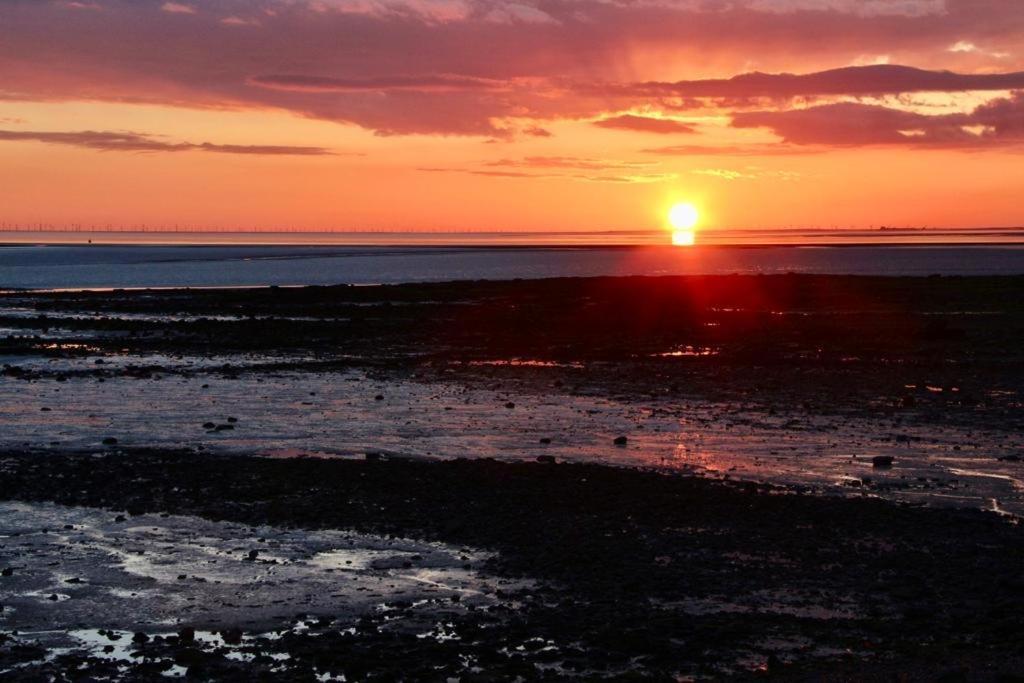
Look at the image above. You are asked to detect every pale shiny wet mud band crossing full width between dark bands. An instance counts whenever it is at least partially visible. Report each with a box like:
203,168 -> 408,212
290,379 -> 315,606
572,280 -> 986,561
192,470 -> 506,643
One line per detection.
6,360 -> 1024,514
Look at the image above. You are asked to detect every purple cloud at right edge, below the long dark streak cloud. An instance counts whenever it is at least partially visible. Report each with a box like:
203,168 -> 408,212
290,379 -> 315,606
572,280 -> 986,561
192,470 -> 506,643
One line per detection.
732,92 -> 1024,147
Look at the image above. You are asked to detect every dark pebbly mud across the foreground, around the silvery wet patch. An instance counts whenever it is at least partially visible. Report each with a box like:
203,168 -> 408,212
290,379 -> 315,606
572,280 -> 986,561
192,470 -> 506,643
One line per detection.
0,452 -> 1024,680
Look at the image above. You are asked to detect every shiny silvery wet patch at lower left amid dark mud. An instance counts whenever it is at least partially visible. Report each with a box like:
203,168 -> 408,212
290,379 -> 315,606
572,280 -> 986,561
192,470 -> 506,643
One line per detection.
0,503 -> 524,647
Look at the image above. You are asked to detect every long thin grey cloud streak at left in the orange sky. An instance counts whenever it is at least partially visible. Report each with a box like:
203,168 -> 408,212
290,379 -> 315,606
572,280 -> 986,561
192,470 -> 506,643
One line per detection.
0,130 -> 335,157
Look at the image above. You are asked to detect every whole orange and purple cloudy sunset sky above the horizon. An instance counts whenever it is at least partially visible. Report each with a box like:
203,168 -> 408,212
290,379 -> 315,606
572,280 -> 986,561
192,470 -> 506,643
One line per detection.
0,0 -> 1024,230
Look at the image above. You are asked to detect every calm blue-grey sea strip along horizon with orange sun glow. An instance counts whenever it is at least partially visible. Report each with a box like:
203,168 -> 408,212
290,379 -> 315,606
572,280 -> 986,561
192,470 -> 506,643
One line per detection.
0,228 -> 1024,290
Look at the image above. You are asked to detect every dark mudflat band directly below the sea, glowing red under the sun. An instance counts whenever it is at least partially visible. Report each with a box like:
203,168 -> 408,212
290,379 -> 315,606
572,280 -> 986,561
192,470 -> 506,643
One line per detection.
0,275 -> 1024,427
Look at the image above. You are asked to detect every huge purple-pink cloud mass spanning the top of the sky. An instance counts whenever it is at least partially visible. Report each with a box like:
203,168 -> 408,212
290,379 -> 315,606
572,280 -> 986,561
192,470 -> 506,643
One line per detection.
6,0 -> 1024,138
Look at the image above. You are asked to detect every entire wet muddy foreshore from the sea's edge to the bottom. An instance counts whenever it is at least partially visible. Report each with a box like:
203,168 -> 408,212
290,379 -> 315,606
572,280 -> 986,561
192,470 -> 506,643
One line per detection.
0,275 -> 1024,680
